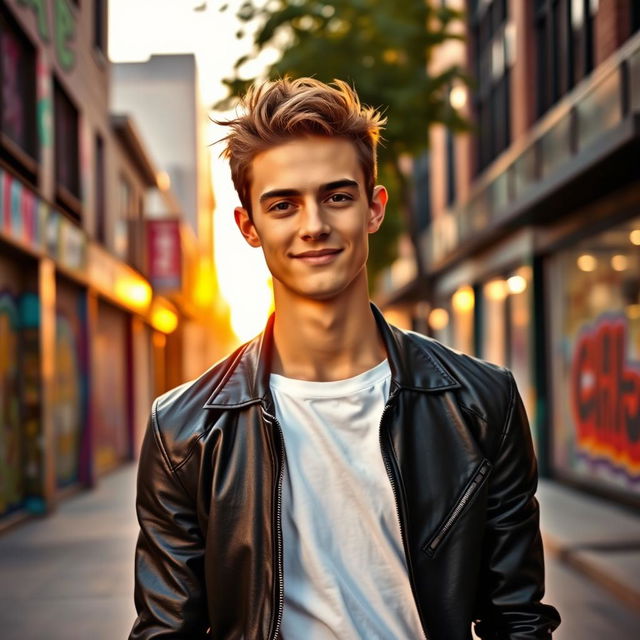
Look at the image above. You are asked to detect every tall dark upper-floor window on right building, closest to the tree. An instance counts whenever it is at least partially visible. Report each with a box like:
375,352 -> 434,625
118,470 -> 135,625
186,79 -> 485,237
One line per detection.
469,0 -> 514,173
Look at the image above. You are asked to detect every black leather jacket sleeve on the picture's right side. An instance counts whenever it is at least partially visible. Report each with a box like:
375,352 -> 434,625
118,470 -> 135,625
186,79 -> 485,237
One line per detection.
475,373 -> 560,640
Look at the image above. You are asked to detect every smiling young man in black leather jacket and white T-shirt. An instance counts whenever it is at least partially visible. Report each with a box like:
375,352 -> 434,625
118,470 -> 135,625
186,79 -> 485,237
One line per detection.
130,78 -> 559,640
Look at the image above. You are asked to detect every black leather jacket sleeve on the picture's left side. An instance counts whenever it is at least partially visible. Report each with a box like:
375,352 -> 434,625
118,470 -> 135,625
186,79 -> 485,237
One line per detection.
129,402 -> 209,640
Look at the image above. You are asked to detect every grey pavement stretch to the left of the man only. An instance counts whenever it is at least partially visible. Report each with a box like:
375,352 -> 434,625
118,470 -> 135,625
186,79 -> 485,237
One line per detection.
0,464 -> 138,640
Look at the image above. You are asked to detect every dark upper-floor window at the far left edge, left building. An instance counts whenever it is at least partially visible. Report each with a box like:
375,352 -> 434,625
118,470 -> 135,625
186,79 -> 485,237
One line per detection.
0,12 -> 37,173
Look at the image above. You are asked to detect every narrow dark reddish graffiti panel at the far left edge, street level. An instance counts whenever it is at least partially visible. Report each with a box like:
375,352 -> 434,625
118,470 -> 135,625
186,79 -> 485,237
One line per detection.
0,291 -> 24,515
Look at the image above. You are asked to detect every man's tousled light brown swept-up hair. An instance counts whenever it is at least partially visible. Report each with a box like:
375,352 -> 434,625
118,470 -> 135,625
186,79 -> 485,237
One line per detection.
219,76 -> 386,214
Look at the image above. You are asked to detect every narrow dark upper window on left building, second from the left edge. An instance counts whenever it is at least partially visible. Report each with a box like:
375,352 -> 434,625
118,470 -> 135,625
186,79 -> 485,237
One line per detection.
53,80 -> 80,218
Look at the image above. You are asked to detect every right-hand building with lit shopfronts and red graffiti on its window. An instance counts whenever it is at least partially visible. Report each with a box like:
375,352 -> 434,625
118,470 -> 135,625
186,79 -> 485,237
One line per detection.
386,0 -> 640,506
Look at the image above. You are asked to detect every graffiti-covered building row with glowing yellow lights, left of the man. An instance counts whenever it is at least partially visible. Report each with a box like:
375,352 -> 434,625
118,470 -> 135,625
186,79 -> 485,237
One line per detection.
0,0 -> 226,527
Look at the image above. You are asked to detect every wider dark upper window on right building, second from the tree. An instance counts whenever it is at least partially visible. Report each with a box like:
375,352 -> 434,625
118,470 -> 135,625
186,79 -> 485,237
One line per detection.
534,0 -> 598,116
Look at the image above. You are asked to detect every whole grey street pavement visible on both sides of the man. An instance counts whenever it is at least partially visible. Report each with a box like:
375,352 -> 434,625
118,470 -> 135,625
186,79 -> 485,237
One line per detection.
0,464 -> 640,640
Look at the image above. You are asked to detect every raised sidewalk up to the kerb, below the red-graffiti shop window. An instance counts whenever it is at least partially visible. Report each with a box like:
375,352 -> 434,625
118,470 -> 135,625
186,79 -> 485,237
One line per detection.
537,480 -> 640,611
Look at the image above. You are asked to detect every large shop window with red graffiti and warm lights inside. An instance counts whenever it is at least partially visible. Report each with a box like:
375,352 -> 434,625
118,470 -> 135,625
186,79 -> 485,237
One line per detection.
548,218 -> 640,495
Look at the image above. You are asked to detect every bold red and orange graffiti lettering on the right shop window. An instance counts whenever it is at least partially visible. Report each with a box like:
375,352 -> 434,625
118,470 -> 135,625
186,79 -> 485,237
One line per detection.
571,315 -> 640,484
